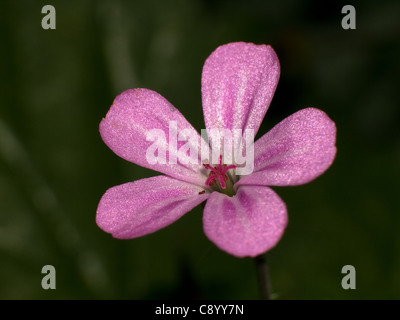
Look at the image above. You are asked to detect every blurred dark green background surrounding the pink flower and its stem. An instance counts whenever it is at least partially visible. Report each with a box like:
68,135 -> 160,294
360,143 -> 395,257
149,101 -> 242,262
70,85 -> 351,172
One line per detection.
0,0 -> 400,299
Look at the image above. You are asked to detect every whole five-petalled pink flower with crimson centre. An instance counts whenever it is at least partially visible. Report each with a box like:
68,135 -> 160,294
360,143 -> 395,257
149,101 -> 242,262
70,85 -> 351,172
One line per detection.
96,42 -> 336,257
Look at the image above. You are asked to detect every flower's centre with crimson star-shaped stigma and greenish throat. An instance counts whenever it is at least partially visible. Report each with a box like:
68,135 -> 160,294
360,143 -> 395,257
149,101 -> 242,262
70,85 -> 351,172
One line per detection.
203,155 -> 236,196
